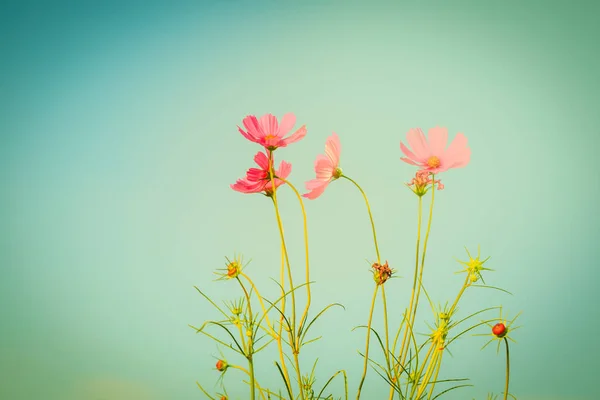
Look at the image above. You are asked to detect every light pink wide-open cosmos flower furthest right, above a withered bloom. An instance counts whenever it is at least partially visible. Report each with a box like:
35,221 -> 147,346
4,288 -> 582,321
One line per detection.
400,126 -> 471,174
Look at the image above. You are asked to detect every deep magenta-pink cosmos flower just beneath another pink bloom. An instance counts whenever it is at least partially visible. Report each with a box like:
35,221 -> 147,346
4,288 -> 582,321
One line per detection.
231,151 -> 292,195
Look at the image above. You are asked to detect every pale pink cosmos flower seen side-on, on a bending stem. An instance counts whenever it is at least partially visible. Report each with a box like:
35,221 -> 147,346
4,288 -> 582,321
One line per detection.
302,133 -> 342,200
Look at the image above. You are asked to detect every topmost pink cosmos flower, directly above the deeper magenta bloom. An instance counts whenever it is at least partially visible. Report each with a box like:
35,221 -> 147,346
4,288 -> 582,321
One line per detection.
238,113 -> 306,151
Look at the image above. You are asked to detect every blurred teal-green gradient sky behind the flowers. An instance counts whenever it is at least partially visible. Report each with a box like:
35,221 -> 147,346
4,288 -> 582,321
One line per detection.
0,0 -> 600,400
